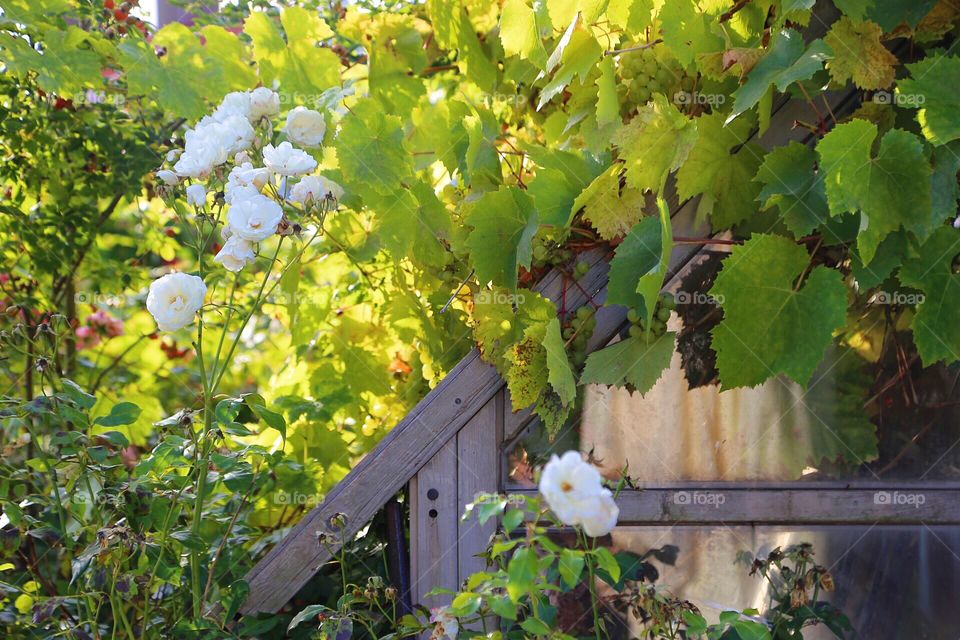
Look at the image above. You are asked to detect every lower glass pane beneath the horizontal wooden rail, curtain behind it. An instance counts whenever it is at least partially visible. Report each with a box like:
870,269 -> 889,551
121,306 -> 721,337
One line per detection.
612,527 -> 960,640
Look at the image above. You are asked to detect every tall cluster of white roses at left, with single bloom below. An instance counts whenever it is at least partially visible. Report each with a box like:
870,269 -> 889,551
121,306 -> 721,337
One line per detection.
147,87 -> 343,331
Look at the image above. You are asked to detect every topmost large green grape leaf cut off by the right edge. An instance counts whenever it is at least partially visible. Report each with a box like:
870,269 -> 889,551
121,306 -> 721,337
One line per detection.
897,55 -> 960,145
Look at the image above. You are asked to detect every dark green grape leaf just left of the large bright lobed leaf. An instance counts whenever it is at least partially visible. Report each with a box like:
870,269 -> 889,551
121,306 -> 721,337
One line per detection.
754,142 -> 830,238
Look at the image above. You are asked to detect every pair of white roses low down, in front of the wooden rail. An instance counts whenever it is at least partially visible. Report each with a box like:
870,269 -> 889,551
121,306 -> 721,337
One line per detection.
540,451 -> 620,538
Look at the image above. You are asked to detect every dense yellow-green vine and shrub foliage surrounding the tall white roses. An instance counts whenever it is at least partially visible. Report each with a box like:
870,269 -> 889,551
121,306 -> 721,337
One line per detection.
0,0 -> 960,637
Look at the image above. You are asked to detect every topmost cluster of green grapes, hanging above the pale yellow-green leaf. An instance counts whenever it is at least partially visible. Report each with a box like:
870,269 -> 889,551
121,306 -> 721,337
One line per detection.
617,44 -> 693,106
